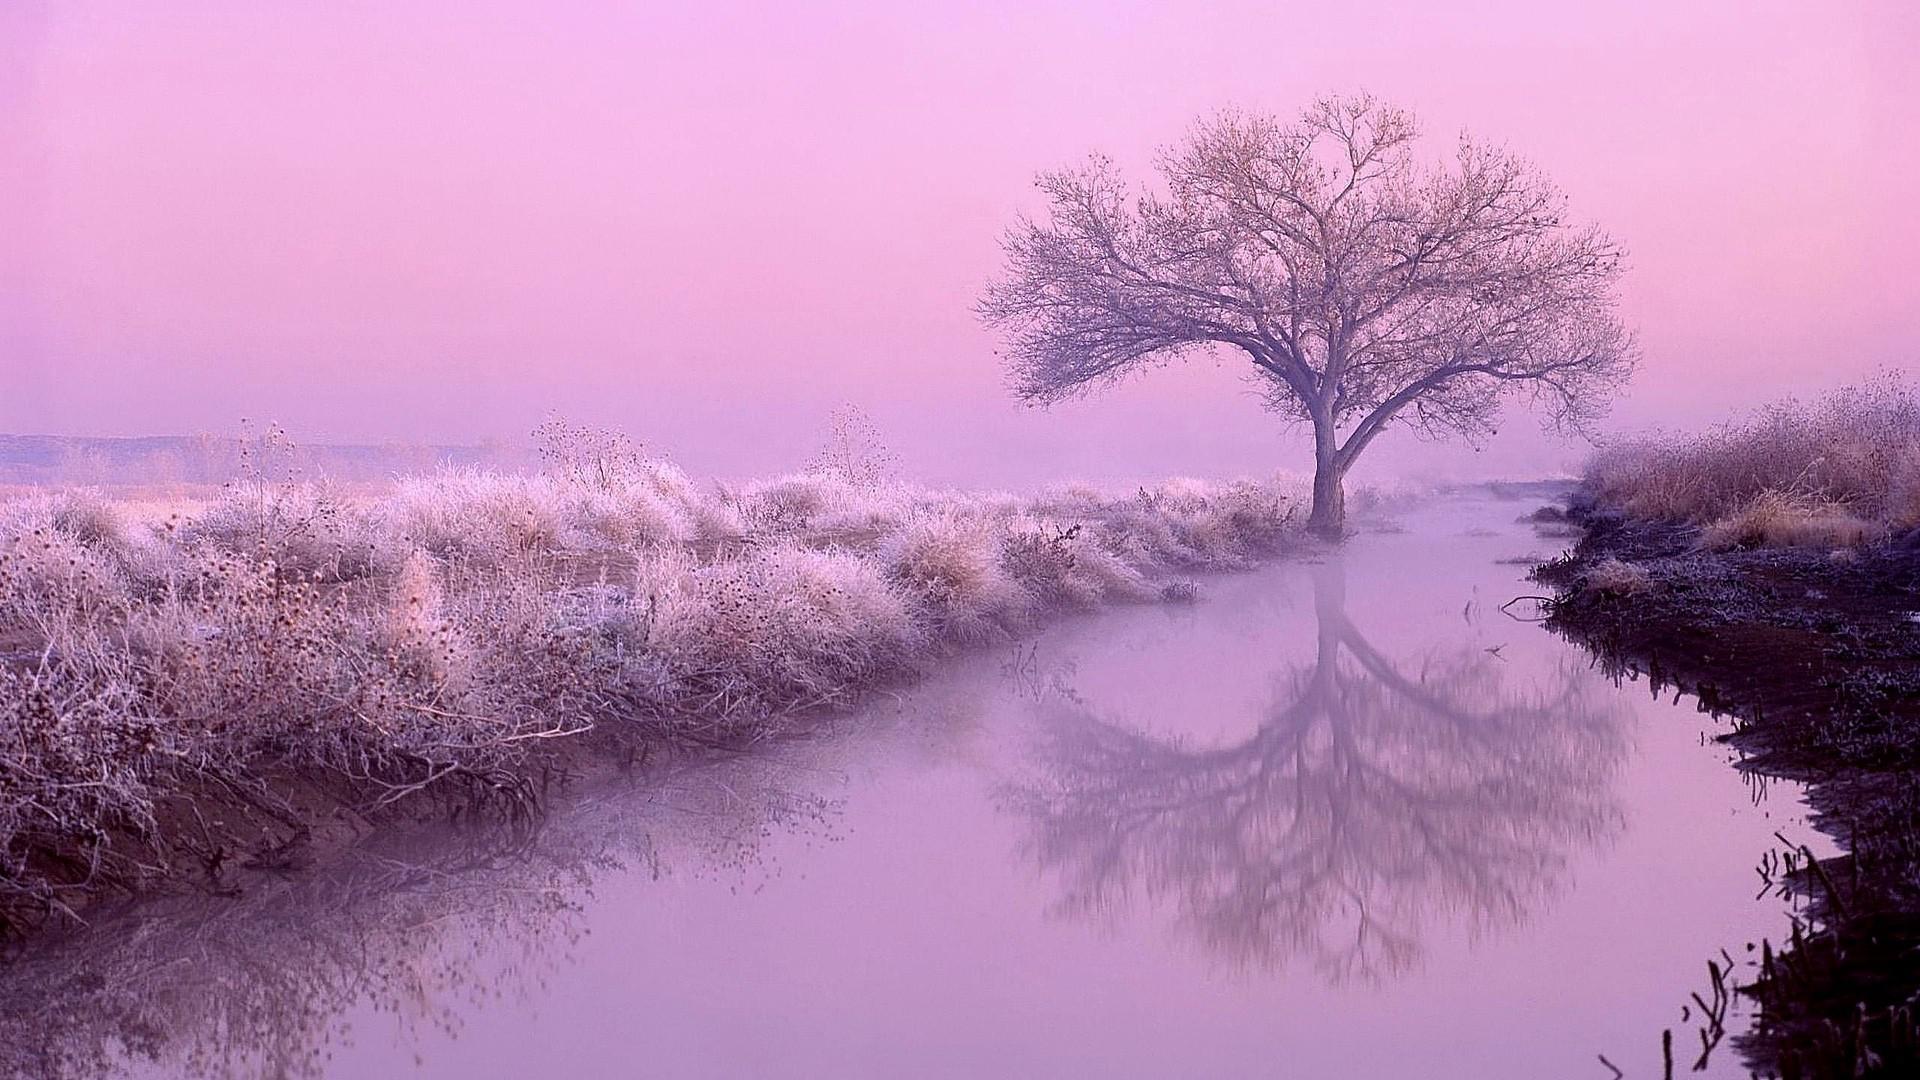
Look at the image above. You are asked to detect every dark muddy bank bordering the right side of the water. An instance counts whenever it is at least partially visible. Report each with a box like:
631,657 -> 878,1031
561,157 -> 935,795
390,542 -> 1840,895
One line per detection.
1534,498 -> 1920,1076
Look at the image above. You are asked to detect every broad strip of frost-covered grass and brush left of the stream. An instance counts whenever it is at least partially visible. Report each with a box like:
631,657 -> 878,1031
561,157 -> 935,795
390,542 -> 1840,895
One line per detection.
0,459 -> 1296,930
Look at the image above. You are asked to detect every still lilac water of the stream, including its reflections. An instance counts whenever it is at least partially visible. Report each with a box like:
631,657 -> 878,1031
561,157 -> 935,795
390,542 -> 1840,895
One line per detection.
40,494 -> 1826,1080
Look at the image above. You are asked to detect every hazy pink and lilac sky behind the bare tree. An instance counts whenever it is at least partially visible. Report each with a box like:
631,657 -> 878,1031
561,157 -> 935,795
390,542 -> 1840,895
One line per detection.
0,0 -> 1920,480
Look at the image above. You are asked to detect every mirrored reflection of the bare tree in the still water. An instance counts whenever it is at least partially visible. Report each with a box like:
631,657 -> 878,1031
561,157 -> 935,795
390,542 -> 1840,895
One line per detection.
1006,561 -> 1626,982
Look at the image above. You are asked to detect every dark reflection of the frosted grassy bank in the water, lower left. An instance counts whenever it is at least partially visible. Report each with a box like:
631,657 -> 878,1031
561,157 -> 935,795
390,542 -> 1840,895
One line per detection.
0,755 -> 835,1078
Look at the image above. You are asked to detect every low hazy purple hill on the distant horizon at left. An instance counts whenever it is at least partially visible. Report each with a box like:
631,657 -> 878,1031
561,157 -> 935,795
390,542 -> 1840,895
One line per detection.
0,434 -> 522,484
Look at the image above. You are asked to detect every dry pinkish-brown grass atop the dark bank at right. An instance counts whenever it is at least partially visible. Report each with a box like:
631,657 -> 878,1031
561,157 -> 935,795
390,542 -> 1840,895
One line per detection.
1586,379 -> 1920,550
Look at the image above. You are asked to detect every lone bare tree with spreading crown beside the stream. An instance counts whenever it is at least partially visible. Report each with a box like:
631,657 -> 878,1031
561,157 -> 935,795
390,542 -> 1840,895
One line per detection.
979,94 -> 1634,534
